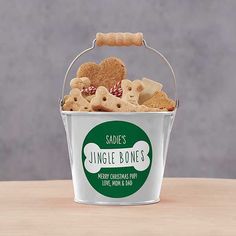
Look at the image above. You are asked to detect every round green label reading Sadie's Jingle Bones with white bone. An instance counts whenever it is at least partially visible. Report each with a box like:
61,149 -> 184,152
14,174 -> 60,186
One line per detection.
82,121 -> 152,198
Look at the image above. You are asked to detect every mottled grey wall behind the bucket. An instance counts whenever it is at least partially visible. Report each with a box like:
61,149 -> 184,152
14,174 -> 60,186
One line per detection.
0,0 -> 236,180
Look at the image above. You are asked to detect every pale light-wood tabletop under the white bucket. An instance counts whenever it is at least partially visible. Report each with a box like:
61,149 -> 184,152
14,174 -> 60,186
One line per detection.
0,178 -> 236,236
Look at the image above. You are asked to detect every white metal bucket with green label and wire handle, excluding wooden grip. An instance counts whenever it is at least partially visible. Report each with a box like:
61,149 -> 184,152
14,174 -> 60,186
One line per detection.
60,33 -> 178,205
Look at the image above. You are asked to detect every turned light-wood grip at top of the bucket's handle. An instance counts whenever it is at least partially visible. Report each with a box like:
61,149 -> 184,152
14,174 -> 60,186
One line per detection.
96,33 -> 143,46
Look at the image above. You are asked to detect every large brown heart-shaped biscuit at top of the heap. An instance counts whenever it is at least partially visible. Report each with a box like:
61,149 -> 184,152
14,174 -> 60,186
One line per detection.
77,57 -> 126,89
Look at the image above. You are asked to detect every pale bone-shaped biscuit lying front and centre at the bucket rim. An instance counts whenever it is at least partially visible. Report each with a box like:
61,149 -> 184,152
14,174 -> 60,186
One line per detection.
90,86 -> 136,112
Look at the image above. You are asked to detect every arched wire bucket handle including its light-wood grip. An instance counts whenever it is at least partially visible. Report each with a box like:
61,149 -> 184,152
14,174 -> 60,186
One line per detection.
61,33 -> 179,108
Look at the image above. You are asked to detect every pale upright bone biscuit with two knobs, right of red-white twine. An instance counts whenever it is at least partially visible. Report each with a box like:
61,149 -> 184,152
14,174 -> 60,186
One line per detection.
121,79 -> 144,105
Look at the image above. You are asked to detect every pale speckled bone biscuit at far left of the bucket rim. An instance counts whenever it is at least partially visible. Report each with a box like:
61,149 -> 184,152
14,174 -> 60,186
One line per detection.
62,88 -> 91,111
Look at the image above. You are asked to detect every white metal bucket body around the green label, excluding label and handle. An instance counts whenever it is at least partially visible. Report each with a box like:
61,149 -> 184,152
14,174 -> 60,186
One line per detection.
61,111 -> 176,205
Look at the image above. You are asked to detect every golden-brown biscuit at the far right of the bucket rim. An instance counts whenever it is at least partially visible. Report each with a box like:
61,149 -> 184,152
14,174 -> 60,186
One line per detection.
143,91 -> 175,111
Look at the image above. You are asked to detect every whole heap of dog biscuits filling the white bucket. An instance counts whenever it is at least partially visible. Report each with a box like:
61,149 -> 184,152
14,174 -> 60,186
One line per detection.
62,57 -> 176,112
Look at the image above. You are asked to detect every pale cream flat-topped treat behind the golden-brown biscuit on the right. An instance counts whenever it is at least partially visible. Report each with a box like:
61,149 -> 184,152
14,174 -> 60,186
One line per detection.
139,78 -> 163,104
